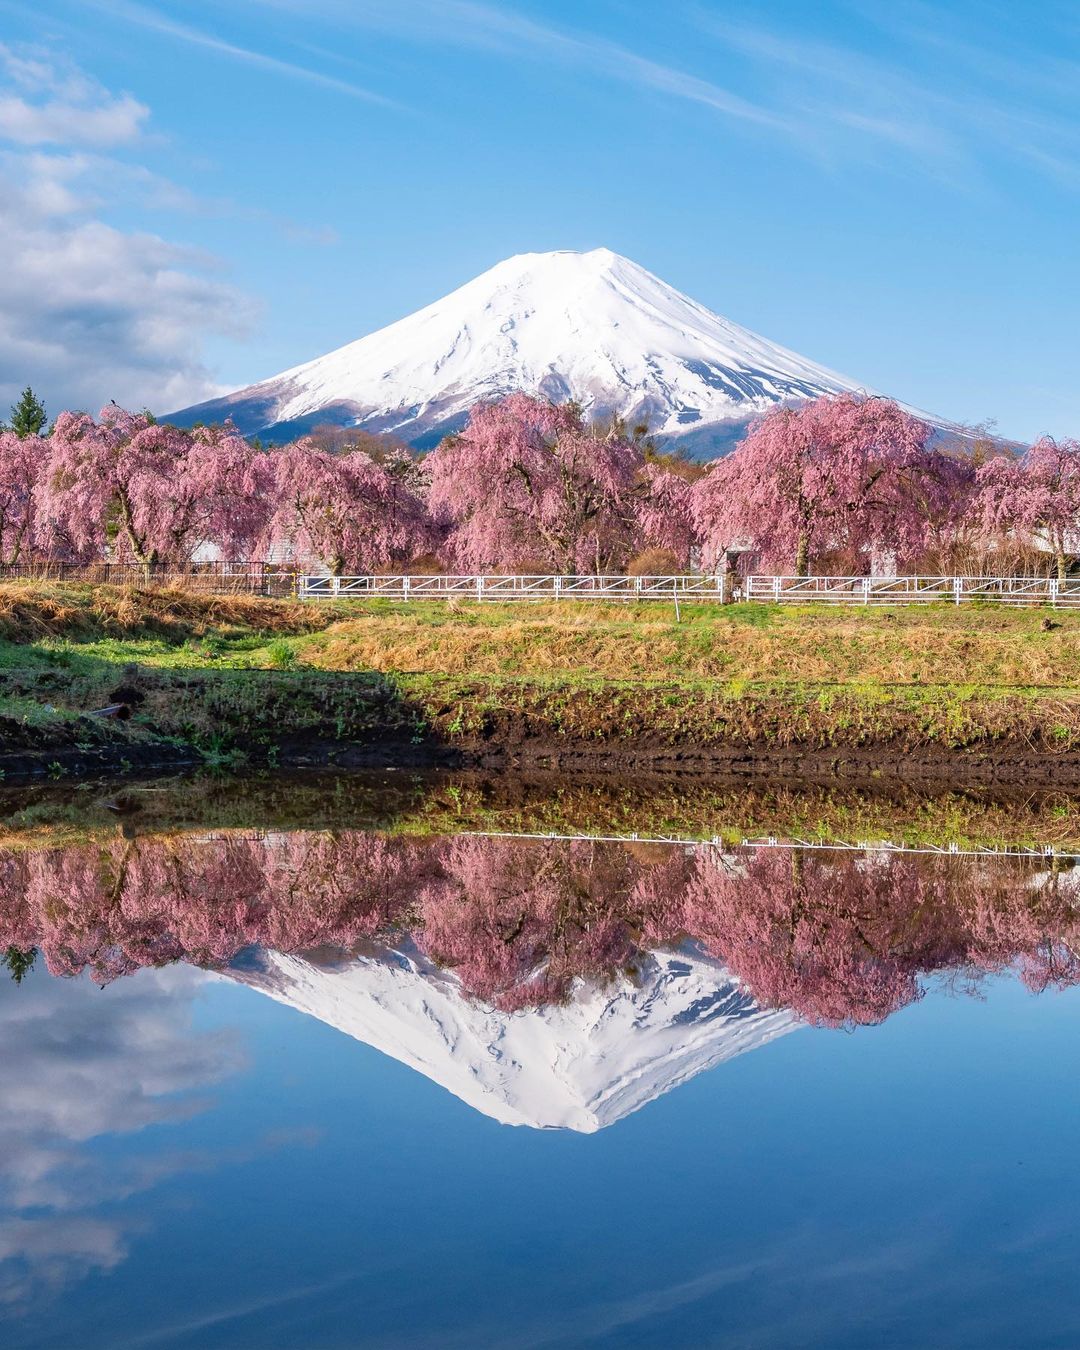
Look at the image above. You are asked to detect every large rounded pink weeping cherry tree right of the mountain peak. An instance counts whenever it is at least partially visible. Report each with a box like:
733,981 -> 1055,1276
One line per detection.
691,394 -> 930,576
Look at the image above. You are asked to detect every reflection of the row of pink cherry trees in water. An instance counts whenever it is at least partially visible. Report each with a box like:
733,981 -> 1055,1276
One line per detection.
0,832 -> 1080,1026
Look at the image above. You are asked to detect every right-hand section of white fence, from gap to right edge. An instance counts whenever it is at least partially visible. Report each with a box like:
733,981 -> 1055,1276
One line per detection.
743,576 -> 1080,605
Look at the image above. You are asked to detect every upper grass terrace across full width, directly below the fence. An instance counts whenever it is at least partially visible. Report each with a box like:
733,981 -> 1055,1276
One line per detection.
0,585 -> 1080,690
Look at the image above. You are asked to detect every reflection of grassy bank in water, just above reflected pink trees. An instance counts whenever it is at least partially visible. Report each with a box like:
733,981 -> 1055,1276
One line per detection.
0,771 -> 1080,853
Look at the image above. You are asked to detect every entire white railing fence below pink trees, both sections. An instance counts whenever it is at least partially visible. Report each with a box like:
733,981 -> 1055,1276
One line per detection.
297,572 -> 1080,606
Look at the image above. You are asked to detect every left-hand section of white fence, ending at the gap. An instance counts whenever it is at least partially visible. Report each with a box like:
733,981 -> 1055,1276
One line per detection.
298,575 -> 730,601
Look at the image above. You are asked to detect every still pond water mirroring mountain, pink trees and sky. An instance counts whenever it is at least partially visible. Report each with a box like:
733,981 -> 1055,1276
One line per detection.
0,780 -> 1080,1350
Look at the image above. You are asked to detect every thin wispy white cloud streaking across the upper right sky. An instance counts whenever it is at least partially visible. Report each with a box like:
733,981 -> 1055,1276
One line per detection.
243,0 -> 1080,186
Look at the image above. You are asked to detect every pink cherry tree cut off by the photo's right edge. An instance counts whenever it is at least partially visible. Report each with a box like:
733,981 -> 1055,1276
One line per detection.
972,436 -> 1080,582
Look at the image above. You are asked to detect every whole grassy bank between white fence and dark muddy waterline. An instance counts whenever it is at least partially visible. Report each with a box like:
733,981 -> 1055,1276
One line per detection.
0,586 -> 1080,782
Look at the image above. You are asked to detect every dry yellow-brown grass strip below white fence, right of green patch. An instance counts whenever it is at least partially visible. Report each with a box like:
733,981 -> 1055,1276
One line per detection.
302,608 -> 1080,689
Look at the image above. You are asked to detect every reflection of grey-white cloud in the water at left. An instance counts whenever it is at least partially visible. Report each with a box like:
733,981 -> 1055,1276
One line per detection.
0,967 -> 238,1303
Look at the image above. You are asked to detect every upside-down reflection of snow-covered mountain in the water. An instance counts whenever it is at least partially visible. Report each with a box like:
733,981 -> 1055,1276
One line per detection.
230,941 -> 798,1133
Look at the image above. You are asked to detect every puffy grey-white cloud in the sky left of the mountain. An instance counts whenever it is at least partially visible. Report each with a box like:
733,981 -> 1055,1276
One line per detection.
0,46 -> 255,416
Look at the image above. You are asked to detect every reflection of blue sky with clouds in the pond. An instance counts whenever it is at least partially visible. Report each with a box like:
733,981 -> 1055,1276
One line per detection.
0,971 -> 1080,1350
